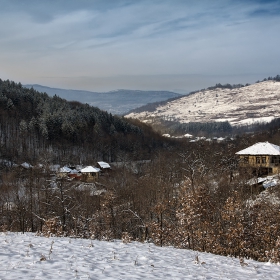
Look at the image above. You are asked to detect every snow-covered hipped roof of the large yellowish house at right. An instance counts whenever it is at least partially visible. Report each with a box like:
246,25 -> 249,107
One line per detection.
236,142 -> 280,156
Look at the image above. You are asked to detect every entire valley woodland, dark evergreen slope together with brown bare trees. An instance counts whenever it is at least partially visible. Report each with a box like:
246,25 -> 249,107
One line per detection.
0,78 -> 280,262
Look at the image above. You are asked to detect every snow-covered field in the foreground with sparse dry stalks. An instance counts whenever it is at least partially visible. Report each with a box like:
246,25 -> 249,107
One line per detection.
0,233 -> 280,280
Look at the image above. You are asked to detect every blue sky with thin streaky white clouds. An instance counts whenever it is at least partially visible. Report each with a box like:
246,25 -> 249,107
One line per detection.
0,0 -> 280,93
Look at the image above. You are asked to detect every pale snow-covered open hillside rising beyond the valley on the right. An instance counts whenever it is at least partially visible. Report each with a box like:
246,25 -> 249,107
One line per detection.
126,81 -> 280,125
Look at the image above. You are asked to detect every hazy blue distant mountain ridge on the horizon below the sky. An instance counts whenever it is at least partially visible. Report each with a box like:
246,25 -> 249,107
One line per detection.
24,84 -> 182,115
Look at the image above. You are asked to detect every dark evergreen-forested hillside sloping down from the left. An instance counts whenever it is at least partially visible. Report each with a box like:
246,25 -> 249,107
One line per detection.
0,80 -> 166,164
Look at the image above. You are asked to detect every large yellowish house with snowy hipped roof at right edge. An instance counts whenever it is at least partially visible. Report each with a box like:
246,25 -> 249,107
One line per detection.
236,142 -> 280,174
